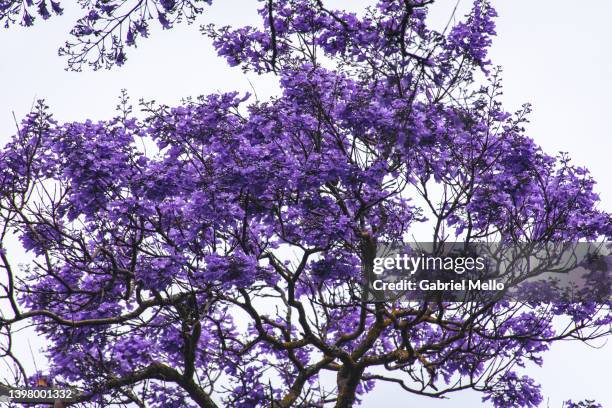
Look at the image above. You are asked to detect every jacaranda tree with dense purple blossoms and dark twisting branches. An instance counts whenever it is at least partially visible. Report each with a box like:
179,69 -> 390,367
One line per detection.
0,0 -> 612,408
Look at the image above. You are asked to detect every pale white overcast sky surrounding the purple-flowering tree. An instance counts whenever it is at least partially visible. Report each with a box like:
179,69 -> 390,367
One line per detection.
0,0 -> 612,408
